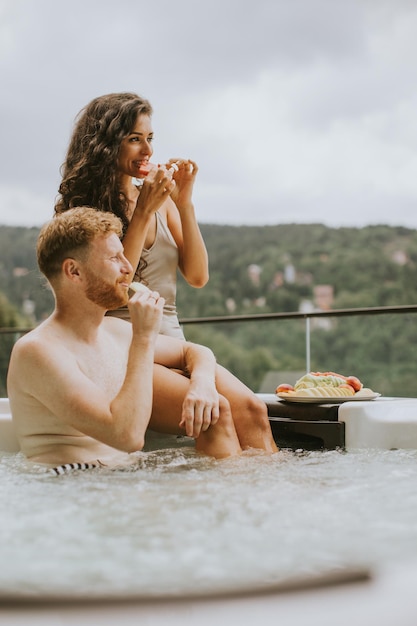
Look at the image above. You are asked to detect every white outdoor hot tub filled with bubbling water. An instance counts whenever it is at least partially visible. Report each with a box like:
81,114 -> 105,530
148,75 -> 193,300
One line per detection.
0,394 -> 417,626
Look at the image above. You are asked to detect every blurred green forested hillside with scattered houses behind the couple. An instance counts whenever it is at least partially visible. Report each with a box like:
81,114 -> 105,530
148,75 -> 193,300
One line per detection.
0,224 -> 417,397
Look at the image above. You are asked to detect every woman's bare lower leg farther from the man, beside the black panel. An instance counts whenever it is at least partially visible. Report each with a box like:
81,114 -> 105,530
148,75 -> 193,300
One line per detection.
216,365 -> 278,453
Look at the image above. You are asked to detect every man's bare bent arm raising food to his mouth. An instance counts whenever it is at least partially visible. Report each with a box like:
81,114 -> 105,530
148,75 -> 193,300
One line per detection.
8,295 -> 163,452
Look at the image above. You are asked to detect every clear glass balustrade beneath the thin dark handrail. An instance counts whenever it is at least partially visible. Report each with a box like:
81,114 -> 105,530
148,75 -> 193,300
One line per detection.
0,305 -> 417,397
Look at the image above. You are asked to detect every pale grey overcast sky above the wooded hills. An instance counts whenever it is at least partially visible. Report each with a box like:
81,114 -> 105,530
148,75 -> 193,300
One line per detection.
0,0 -> 417,228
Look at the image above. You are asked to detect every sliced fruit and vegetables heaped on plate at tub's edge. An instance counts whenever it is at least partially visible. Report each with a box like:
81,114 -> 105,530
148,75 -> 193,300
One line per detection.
275,372 -> 374,398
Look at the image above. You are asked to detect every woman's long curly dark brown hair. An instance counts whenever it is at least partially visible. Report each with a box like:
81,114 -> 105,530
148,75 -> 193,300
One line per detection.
55,92 -> 152,230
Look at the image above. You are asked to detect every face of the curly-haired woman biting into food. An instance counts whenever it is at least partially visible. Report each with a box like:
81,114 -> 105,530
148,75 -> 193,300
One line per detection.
117,113 -> 153,177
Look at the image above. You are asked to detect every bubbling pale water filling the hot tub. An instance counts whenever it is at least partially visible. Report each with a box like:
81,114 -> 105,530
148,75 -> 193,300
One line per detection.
0,446 -> 417,597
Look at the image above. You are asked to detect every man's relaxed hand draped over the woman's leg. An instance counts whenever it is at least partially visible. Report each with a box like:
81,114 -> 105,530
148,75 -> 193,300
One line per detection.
179,380 -> 219,439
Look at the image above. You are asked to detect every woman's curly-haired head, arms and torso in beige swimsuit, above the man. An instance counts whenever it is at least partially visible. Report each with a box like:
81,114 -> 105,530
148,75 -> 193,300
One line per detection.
55,93 -> 208,339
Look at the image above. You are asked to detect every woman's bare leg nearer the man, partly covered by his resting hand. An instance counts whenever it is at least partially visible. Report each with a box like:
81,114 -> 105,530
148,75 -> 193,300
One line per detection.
149,364 -> 242,459
